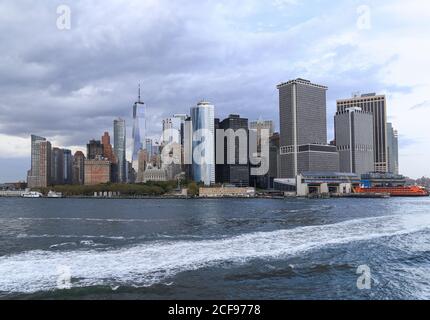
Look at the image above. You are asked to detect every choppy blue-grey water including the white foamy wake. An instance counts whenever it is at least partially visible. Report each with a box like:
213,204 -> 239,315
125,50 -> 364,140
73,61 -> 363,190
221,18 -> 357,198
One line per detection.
0,198 -> 430,299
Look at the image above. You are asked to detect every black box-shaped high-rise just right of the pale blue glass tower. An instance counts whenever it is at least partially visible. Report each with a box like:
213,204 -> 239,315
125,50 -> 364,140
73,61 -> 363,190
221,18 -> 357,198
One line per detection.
215,115 -> 249,186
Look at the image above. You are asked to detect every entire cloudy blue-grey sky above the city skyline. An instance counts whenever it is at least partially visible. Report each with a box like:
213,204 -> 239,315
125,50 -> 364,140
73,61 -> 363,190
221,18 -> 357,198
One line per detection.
0,0 -> 430,182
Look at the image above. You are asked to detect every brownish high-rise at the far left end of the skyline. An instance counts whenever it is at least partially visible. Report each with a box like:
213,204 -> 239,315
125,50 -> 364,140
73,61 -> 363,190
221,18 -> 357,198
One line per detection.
27,135 -> 52,188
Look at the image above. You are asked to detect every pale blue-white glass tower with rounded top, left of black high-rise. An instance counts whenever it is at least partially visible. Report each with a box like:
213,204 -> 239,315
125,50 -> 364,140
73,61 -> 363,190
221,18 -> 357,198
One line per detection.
191,101 -> 215,185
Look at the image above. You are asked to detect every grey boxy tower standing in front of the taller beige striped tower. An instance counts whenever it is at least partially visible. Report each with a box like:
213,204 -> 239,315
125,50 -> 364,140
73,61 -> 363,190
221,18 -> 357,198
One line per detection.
335,107 -> 374,175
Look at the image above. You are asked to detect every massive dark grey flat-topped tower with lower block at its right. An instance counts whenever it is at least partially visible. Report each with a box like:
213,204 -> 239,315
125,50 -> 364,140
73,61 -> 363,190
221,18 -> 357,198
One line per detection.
277,79 -> 339,178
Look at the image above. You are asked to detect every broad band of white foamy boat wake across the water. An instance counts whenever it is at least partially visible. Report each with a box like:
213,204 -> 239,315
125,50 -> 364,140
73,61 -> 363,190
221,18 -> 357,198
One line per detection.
0,213 -> 430,295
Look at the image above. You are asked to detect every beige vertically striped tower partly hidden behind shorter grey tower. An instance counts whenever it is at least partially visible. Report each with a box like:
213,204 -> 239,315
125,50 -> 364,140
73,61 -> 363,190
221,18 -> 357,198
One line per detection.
337,93 -> 388,173
